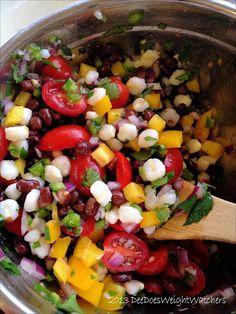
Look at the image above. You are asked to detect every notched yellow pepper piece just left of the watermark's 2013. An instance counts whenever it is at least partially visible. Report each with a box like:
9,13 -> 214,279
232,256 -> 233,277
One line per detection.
76,280 -> 104,307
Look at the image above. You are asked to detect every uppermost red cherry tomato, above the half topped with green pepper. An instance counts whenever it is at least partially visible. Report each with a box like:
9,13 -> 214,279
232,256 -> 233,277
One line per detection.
43,56 -> 72,80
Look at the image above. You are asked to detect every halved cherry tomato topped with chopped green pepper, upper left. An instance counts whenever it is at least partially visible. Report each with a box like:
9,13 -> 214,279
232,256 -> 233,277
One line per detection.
42,81 -> 87,117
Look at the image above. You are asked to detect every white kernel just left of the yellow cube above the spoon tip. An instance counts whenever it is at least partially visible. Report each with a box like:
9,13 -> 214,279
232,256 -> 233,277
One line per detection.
118,202 -> 143,224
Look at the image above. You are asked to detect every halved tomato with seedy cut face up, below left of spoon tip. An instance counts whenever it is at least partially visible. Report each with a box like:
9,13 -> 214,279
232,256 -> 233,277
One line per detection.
102,232 -> 149,273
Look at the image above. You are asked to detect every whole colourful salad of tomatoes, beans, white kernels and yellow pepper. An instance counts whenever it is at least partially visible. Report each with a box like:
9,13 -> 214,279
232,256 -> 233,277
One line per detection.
0,11 -> 232,313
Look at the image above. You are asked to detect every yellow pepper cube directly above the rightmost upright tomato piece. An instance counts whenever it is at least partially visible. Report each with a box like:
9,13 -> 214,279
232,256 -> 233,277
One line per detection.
157,130 -> 183,148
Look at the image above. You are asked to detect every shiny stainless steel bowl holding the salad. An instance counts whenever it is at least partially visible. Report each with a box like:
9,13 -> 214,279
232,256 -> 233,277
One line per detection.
0,0 -> 236,314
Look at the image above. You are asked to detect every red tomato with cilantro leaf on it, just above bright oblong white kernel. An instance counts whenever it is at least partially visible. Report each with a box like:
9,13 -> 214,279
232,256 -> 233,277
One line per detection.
70,154 -> 105,196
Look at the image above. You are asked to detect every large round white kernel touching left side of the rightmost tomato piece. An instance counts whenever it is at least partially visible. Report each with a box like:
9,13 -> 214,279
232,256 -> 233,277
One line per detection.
140,158 -> 166,182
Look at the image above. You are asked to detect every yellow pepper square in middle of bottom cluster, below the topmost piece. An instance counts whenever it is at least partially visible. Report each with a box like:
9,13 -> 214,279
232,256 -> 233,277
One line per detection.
67,256 -> 98,291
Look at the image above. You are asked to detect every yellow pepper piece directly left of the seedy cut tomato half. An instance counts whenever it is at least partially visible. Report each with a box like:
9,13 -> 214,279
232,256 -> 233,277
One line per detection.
73,237 -> 103,267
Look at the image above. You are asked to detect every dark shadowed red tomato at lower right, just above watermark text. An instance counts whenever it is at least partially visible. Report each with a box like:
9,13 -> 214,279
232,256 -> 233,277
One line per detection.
161,262 -> 205,297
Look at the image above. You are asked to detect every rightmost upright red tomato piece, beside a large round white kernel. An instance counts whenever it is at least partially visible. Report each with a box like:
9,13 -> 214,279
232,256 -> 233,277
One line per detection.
164,148 -> 183,183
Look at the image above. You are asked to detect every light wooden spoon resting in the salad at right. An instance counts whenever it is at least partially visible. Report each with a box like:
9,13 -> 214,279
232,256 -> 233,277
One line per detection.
150,196 -> 236,244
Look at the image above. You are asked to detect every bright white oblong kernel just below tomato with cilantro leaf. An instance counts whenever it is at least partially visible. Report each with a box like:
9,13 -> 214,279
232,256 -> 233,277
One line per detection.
90,181 -> 112,206
